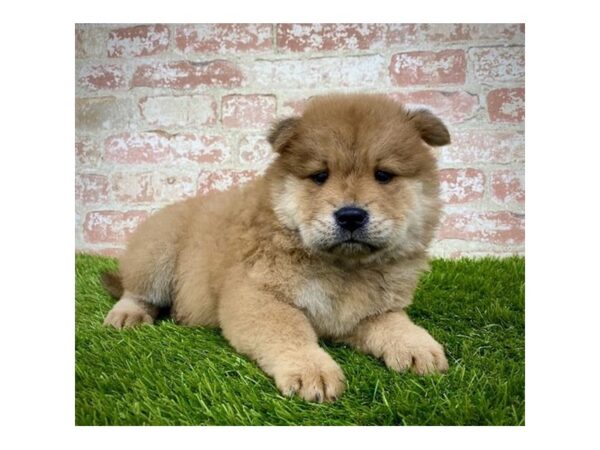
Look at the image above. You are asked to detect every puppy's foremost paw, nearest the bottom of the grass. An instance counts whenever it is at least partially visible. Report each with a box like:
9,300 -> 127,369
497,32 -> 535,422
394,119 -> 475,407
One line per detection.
275,360 -> 346,403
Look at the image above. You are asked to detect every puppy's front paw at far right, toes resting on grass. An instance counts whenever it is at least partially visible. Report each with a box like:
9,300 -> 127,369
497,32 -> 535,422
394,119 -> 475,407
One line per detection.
383,326 -> 448,375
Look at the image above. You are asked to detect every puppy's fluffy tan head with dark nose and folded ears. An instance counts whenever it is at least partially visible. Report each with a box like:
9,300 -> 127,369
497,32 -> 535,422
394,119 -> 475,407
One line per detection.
268,95 -> 450,260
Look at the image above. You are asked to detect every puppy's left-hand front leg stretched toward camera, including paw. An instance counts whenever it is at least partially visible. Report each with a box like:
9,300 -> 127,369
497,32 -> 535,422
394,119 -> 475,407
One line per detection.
219,283 -> 345,402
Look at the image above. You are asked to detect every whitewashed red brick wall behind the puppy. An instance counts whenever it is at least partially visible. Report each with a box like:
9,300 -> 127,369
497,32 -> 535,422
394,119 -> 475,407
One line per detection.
75,24 -> 525,257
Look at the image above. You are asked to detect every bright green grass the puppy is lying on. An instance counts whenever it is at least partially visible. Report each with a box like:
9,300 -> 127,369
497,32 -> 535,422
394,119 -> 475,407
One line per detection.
75,255 -> 525,425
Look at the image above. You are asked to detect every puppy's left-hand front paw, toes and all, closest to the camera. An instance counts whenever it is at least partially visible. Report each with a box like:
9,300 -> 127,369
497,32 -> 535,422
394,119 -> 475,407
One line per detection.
275,349 -> 346,403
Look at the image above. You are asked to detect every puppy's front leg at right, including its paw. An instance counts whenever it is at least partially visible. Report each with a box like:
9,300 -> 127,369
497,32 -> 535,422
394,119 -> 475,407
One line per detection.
342,311 -> 448,375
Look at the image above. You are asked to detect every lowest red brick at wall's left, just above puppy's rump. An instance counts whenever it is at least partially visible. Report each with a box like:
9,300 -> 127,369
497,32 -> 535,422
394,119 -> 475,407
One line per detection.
83,211 -> 149,244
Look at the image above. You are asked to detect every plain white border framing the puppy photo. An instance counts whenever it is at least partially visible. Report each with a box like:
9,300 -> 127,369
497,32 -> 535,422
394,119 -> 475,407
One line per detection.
0,0 -> 600,449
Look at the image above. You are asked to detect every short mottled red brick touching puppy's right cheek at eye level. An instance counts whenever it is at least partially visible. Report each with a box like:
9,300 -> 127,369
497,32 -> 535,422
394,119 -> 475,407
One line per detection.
439,168 -> 485,204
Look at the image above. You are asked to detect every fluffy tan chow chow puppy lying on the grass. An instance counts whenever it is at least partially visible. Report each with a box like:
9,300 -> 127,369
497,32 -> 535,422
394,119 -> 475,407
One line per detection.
105,95 -> 450,402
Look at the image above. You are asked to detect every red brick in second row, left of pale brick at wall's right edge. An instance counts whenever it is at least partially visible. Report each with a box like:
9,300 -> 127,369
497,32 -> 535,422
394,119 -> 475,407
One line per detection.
389,50 -> 467,86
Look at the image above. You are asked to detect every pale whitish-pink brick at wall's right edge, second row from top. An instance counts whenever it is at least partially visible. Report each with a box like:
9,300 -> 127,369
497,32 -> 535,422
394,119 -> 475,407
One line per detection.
469,47 -> 525,82
